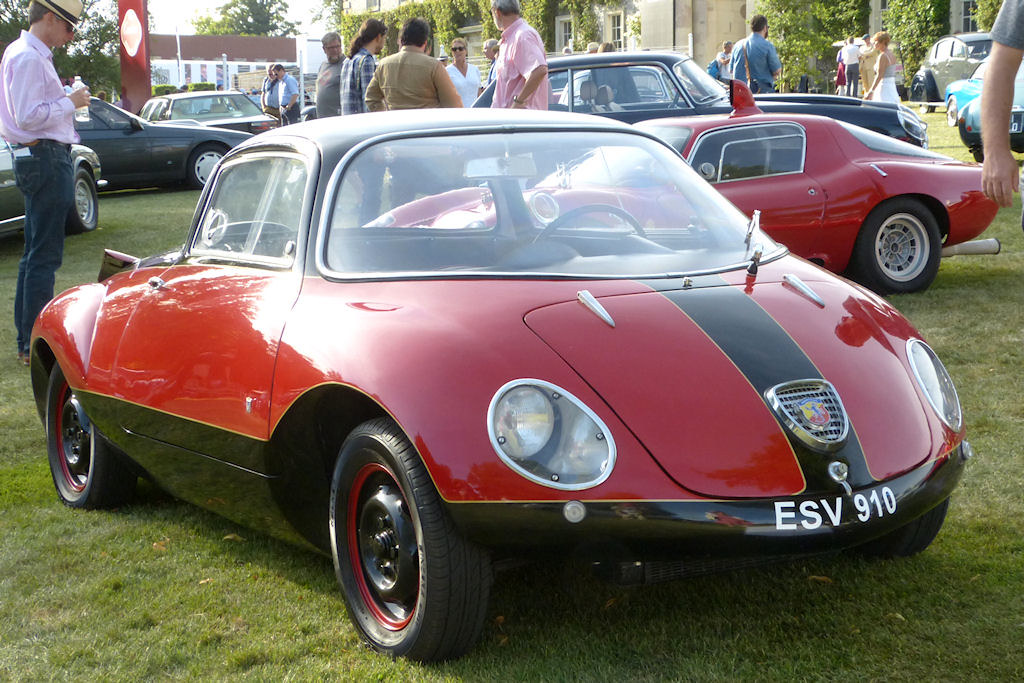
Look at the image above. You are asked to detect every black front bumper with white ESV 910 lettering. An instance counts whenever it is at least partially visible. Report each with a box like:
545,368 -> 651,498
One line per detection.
449,442 -> 970,560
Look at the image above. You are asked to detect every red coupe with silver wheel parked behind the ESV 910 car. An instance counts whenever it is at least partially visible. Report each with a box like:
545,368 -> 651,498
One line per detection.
637,81 -> 998,293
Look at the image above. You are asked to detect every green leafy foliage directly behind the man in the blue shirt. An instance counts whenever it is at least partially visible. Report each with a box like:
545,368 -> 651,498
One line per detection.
757,0 -> 870,91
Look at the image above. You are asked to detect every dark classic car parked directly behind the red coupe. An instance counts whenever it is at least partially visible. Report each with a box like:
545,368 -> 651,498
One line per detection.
473,52 -> 928,146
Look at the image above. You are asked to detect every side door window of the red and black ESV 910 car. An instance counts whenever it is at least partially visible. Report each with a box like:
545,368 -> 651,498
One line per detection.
193,155 -> 307,266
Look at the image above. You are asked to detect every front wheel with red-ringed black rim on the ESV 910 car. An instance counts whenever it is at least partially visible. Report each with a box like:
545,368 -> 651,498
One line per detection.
330,418 -> 492,661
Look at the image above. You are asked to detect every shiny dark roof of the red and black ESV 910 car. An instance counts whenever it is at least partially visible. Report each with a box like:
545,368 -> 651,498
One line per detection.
237,109 -> 636,151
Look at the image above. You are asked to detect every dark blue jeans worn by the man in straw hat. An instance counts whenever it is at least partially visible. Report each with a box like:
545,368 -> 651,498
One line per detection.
14,140 -> 74,353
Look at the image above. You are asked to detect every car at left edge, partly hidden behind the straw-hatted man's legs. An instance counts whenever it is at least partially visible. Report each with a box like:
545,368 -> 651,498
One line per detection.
0,138 -> 105,237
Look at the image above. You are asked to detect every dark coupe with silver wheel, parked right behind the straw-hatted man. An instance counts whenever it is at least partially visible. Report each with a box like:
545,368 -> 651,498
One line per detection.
75,97 -> 251,188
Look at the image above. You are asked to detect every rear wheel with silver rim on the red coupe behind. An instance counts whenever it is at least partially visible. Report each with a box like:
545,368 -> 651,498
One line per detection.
850,198 -> 942,294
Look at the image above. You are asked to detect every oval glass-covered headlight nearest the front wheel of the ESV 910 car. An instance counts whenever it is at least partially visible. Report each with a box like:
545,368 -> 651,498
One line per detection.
487,379 -> 615,490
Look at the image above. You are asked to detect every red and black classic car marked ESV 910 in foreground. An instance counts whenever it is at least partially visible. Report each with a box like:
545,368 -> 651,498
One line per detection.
31,110 -> 971,660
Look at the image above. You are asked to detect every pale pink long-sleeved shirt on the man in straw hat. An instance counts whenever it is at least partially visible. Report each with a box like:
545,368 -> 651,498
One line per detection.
0,31 -> 80,144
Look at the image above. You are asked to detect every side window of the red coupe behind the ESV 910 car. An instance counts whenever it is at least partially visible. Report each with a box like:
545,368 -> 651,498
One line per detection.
689,124 -> 806,183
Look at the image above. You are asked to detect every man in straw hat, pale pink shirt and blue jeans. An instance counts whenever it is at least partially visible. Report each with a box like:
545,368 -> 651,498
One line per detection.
0,0 -> 89,365
